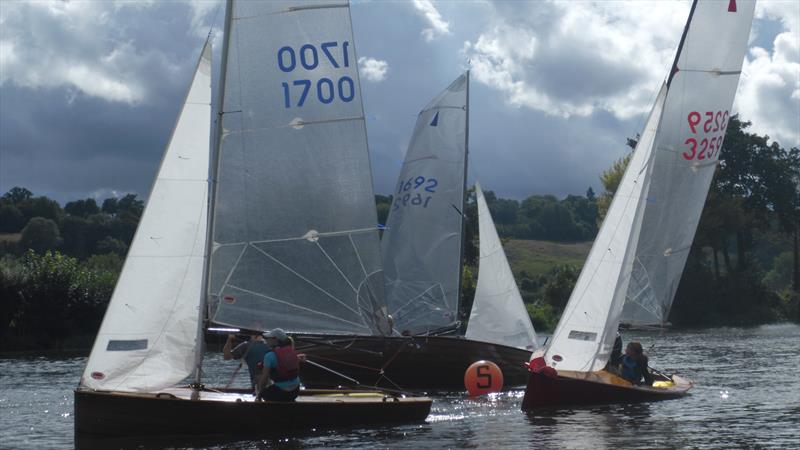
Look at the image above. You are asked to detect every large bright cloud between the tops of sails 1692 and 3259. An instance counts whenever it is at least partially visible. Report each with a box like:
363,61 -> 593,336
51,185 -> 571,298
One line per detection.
461,2 -> 688,119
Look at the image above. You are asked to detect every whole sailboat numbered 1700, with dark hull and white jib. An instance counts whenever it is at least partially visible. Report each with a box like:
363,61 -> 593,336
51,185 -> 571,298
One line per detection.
75,0 -> 431,438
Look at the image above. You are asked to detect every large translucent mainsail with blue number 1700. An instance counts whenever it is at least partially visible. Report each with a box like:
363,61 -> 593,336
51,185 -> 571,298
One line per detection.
209,0 -> 389,335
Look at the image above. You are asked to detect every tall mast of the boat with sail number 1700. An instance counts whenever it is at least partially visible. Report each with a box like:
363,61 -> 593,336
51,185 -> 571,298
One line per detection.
194,0 -> 233,386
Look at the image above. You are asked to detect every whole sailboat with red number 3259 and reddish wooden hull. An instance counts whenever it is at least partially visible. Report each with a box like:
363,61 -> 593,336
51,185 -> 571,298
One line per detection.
522,0 -> 755,410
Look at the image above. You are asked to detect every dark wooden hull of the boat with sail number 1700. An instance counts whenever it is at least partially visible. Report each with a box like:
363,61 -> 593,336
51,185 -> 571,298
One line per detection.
75,388 -> 432,439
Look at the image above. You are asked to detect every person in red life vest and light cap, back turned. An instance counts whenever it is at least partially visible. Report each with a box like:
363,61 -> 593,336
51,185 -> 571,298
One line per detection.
256,328 -> 301,402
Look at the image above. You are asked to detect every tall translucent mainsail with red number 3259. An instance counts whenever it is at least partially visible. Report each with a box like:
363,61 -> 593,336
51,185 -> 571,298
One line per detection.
622,0 -> 755,325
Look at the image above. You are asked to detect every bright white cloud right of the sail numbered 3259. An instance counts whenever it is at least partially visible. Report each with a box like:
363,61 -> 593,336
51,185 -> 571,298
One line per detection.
735,1 -> 800,148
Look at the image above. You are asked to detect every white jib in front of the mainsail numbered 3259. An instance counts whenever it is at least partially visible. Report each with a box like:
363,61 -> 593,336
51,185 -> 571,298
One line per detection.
545,84 -> 667,371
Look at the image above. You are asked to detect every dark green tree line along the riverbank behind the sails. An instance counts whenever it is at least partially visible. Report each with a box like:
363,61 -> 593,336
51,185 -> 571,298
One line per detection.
0,113 -> 800,349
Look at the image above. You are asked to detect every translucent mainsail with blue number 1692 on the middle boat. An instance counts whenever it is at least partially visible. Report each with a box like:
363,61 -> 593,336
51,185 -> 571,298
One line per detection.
382,74 -> 468,334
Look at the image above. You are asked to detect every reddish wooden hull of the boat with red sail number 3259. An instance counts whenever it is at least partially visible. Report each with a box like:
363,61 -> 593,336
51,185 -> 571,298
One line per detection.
522,371 -> 692,411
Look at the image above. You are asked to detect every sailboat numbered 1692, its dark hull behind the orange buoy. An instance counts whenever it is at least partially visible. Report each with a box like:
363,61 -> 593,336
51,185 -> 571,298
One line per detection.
300,72 -> 536,390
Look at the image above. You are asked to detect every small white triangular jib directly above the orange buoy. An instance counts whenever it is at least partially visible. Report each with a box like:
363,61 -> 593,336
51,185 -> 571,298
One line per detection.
466,183 -> 538,350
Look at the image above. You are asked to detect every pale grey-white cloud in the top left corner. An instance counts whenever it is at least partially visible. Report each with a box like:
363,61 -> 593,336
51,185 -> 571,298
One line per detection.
0,1 -> 213,106
